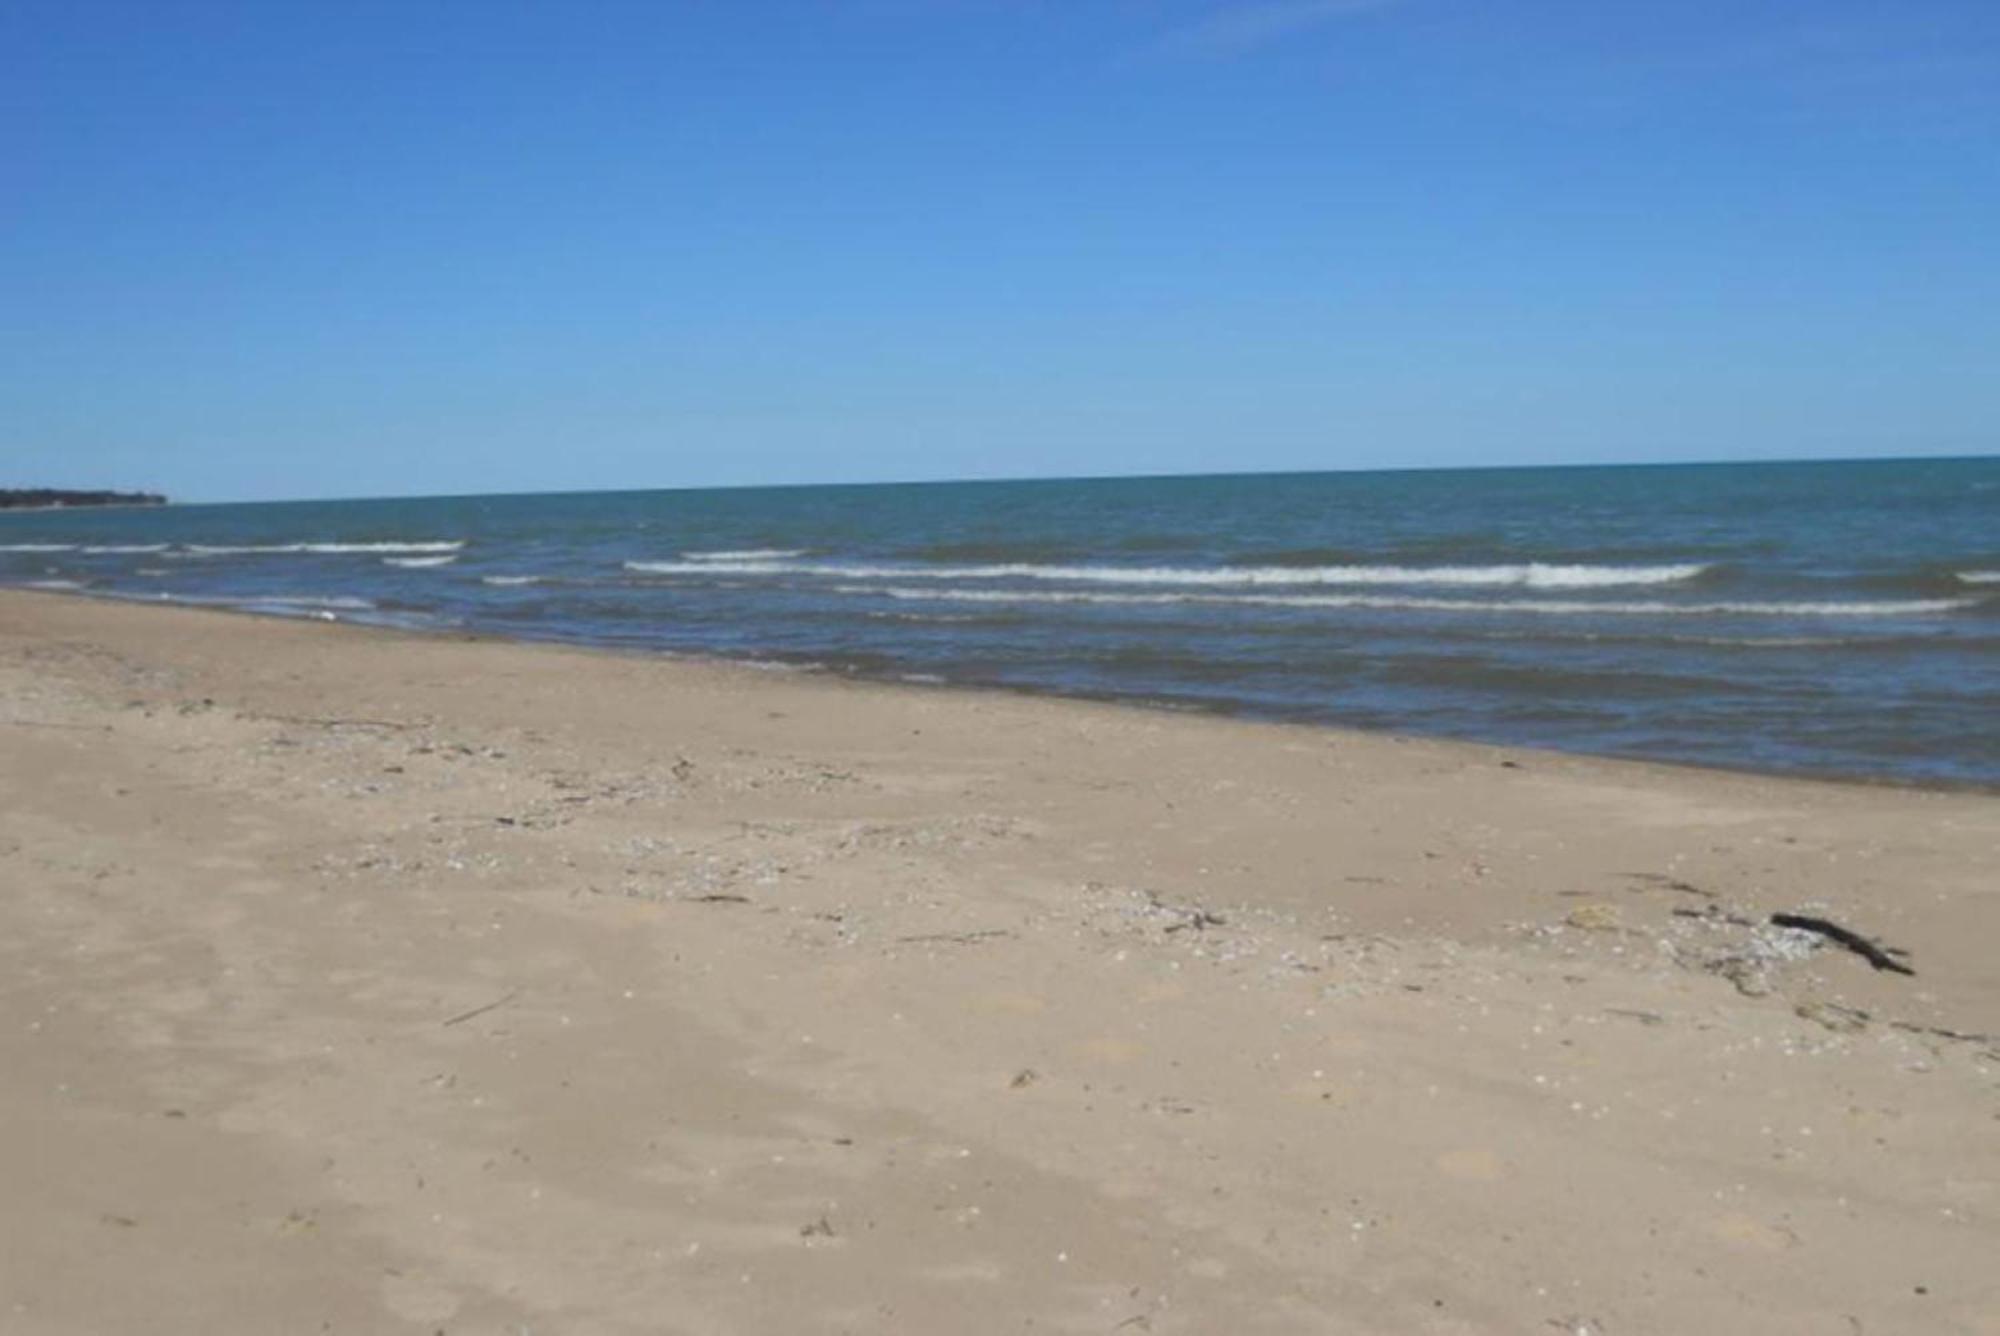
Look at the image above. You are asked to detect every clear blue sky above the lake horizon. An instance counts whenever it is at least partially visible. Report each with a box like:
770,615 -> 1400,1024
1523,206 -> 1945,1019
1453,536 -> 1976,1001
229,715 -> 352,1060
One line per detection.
0,0 -> 2000,500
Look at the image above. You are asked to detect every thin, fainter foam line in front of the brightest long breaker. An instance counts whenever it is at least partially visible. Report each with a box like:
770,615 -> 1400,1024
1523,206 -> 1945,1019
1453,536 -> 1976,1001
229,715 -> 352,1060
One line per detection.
834,584 -> 1982,616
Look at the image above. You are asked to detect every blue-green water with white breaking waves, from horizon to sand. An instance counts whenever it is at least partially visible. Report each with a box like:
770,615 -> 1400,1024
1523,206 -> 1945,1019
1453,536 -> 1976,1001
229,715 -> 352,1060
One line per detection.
0,458 -> 2000,784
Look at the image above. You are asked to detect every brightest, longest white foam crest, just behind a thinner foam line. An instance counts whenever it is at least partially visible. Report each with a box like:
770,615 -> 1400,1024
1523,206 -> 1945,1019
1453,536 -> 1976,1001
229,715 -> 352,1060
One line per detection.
626,556 -> 1708,590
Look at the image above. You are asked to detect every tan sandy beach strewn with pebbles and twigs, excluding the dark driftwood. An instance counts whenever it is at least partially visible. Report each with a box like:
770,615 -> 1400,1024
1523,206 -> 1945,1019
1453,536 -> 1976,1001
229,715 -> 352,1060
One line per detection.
0,592 -> 2000,1336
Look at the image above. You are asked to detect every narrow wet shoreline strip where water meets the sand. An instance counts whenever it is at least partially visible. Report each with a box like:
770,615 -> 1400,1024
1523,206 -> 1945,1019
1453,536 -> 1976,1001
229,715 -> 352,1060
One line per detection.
19,584 -> 2000,796
